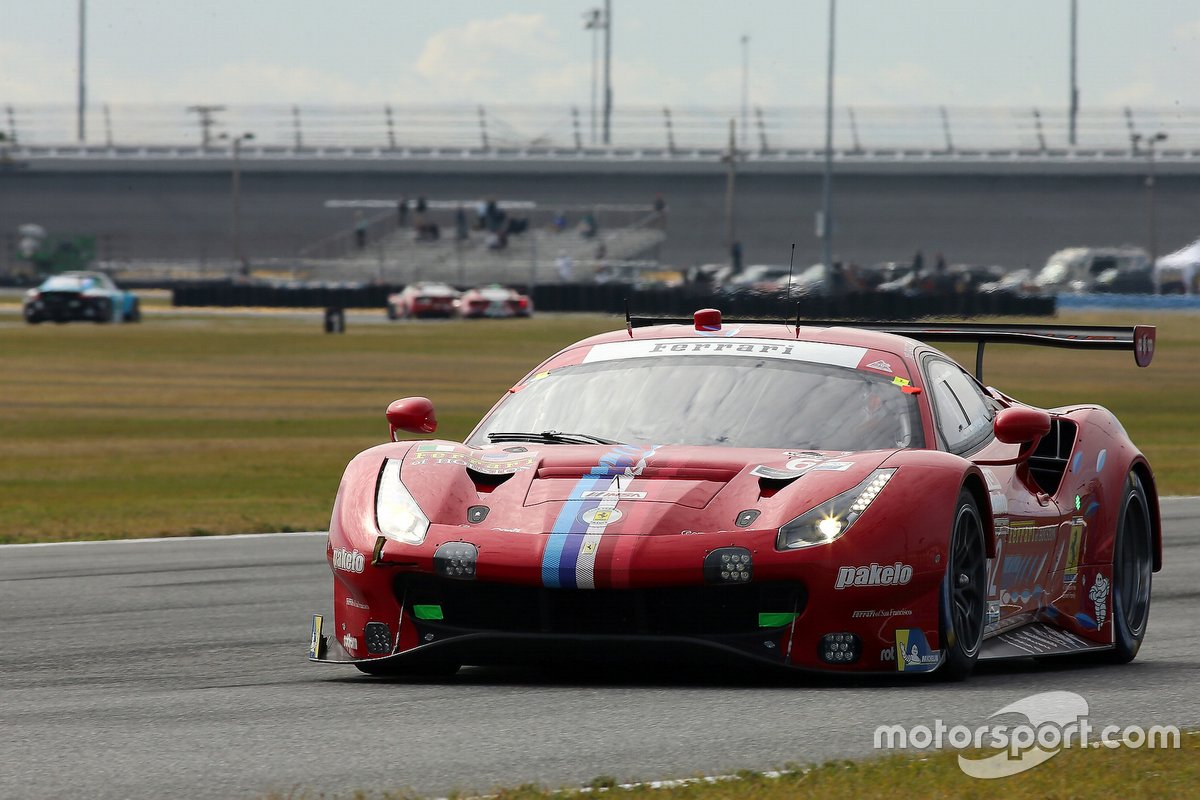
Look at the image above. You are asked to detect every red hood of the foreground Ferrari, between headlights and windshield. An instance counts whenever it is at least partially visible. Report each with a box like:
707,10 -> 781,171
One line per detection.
401,441 -> 895,535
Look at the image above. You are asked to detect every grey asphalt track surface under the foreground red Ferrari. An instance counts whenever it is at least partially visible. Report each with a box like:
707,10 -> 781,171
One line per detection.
0,498 -> 1200,799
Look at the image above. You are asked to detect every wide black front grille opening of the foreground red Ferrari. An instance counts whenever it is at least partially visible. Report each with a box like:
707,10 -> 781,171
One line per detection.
395,575 -> 806,636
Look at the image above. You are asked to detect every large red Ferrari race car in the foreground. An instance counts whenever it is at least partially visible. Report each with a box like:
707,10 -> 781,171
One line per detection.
310,309 -> 1162,679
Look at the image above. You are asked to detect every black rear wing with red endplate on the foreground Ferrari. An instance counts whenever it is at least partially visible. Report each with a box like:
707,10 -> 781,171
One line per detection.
625,312 -> 1157,383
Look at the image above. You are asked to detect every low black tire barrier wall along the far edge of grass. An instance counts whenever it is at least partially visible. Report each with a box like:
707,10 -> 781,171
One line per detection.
173,282 -> 1055,320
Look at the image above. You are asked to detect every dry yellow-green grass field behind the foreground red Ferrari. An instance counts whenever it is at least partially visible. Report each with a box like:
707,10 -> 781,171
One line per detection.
0,308 -> 1200,542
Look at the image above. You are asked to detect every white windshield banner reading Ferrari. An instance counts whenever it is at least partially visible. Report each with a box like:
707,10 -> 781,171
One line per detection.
583,338 -> 866,369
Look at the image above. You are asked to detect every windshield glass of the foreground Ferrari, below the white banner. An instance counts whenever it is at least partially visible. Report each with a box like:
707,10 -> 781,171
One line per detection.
467,355 -> 924,450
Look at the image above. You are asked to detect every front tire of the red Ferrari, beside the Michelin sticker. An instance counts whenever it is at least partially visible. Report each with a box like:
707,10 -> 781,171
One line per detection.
934,489 -> 988,681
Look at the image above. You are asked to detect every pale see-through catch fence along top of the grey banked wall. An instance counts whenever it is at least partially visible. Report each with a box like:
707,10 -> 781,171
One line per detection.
0,104 -> 1200,153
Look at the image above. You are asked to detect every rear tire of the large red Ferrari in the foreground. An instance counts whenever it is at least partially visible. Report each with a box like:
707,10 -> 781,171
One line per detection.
1093,473 -> 1154,664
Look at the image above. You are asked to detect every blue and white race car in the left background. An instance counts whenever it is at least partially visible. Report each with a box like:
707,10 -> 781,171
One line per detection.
23,271 -> 142,325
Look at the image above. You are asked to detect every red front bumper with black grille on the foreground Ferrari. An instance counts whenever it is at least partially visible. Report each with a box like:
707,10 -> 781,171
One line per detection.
310,527 -> 942,674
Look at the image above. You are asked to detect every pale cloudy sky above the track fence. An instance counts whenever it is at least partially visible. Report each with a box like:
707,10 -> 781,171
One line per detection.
0,0 -> 1200,108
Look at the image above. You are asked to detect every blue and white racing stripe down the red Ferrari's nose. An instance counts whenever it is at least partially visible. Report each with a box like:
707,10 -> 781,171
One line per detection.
541,445 -> 656,589
